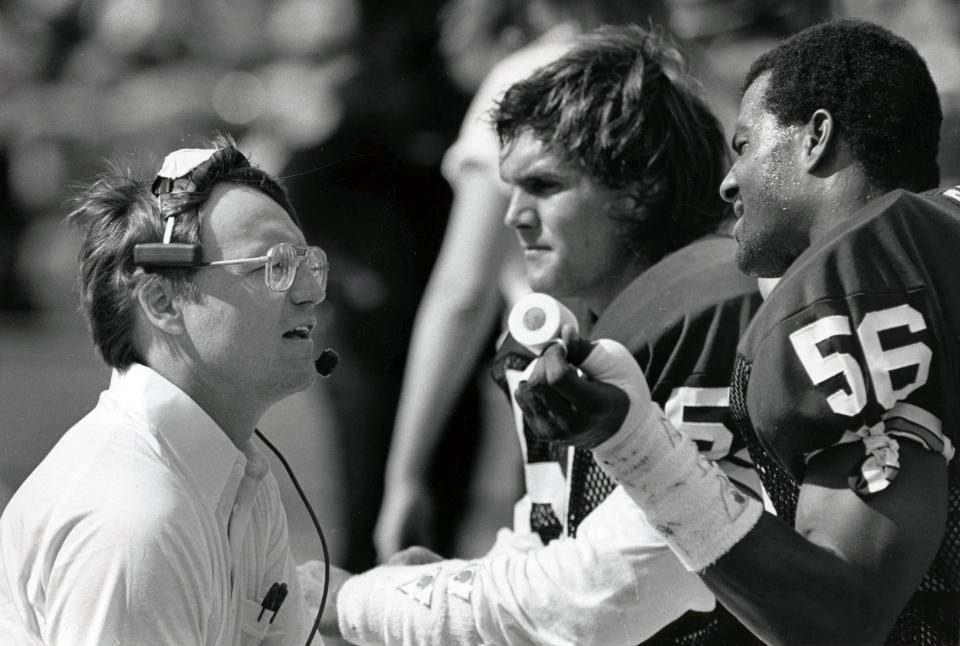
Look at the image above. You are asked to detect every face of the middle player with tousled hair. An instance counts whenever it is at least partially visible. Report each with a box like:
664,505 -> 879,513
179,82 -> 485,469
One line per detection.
500,133 -> 642,312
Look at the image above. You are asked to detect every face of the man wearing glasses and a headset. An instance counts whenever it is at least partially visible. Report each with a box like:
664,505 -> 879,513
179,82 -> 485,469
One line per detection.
184,183 -> 324,405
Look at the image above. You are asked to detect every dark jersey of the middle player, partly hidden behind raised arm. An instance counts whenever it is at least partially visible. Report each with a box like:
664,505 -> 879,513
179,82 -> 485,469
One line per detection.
492,236 -> 761,645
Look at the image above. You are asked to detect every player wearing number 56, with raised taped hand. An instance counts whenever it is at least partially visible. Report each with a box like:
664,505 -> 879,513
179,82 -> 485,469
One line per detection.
517,21 -> 960,644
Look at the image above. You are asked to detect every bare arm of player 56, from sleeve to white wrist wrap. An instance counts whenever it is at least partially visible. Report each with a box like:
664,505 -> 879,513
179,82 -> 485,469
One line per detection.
702,441 -> 947,644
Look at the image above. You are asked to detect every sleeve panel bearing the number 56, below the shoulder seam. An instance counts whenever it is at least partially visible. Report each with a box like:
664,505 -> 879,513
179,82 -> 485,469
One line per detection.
748,292 -> 952,475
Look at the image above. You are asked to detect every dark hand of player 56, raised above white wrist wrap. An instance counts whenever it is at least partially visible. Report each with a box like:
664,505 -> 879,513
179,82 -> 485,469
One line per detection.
515,326 -> 632,449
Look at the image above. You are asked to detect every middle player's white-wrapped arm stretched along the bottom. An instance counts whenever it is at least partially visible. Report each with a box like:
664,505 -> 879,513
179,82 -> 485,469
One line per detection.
338,489 -> 714,646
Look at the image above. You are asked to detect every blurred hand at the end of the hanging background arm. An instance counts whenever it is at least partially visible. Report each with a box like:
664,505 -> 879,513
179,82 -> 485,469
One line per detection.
373,480 -> 434,562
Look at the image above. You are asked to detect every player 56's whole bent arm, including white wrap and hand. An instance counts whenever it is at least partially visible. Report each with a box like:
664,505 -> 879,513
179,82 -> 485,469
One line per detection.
517,342 -> 946,644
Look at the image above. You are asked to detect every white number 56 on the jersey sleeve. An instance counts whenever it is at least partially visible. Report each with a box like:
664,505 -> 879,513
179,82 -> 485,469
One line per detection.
790,305 -> 933,417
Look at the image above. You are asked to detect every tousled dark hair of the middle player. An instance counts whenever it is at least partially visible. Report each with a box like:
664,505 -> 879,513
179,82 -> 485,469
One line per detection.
493,25 -> 729,262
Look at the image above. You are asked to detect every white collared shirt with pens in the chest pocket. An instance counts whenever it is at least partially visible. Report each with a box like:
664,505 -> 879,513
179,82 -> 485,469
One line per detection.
0,364 -> 310,646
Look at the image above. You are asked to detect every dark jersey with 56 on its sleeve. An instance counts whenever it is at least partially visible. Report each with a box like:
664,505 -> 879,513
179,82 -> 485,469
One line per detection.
731,188 -> 960,644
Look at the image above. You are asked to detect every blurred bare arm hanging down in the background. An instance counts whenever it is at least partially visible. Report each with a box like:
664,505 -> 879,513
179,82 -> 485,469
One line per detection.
375,170 -> 516,558
